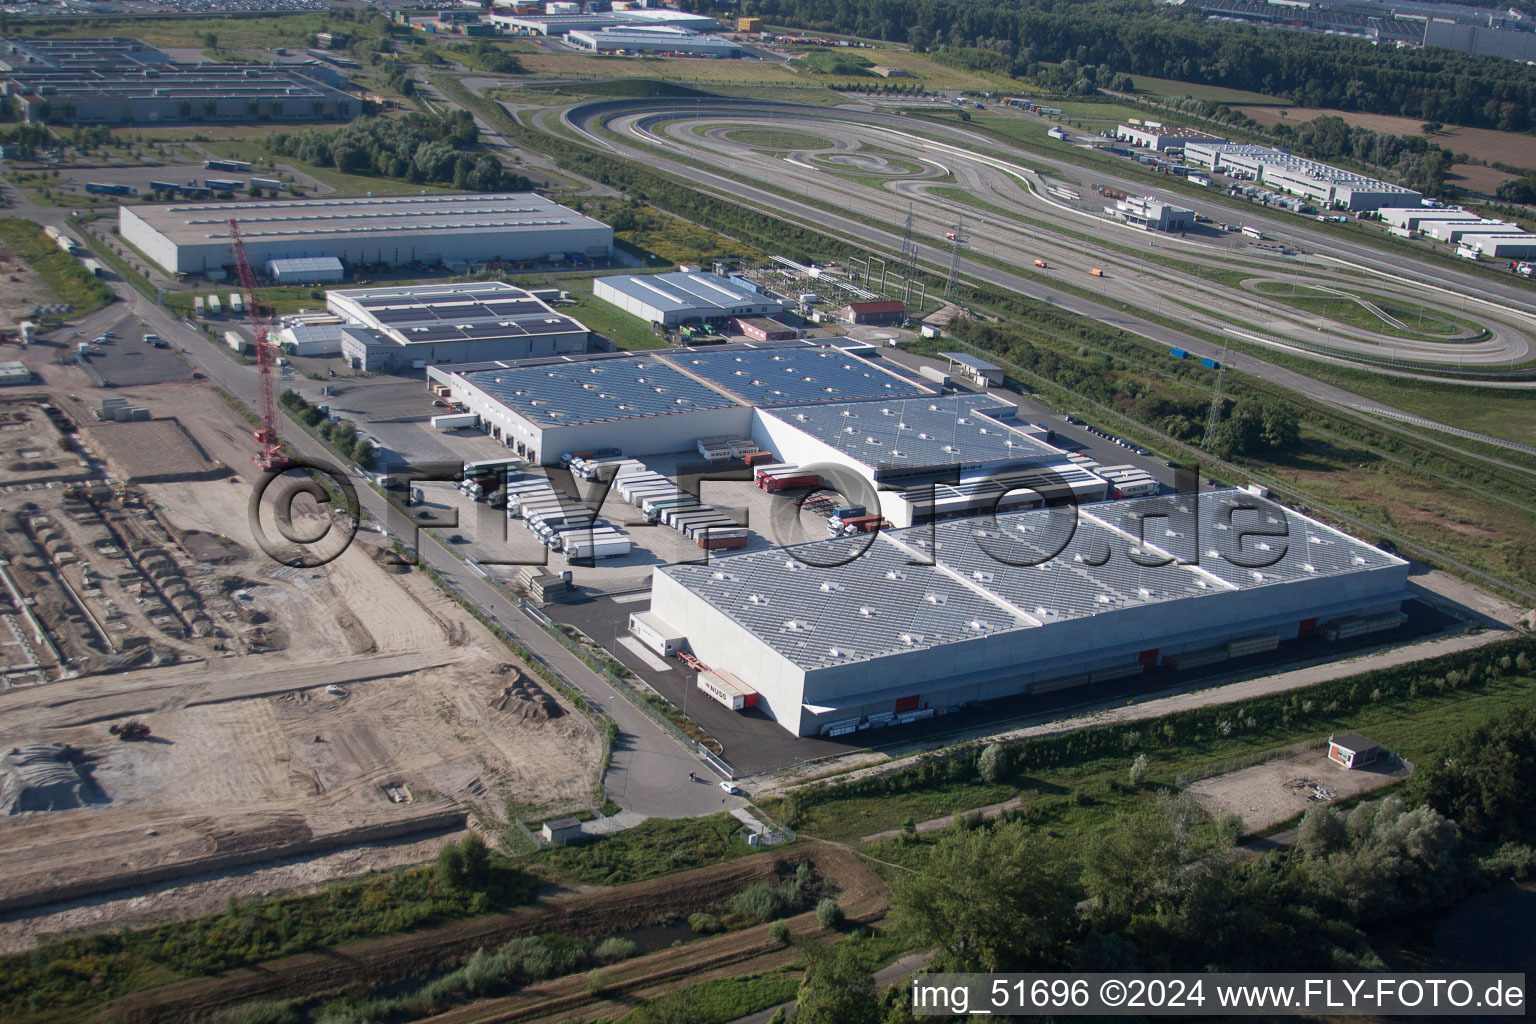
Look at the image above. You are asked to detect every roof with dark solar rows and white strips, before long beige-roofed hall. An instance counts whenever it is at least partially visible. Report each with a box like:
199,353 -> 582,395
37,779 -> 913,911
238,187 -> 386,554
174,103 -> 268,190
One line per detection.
326,281 -> 587,345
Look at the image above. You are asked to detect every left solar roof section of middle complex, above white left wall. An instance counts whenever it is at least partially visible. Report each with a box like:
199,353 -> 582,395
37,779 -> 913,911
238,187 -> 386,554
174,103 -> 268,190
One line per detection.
462,356 -> 737,427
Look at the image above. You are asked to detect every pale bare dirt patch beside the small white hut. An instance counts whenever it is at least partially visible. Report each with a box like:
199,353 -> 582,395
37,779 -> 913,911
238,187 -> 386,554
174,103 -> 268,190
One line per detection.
1189,746 -> 1409,832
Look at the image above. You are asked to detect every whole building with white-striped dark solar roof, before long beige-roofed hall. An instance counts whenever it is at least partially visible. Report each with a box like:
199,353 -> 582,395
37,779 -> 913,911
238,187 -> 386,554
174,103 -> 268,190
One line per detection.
326,281 -> 588,370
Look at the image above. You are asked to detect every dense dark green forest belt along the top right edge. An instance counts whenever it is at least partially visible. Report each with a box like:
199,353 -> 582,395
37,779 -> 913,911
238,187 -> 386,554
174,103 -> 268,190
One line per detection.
742,0 -> 1536,130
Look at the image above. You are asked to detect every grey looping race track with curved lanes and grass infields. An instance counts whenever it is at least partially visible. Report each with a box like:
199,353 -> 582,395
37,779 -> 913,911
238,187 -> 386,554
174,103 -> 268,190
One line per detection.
552,100 -> 1536,386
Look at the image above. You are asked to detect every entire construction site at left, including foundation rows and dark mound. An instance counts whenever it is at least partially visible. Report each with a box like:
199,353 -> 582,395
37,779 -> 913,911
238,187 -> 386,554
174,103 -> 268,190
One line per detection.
0,367 -> 602,947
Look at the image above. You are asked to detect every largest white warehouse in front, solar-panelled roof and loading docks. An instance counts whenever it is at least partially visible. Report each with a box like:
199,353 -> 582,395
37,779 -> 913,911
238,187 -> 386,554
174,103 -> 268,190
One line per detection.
651,490 -> 1409,735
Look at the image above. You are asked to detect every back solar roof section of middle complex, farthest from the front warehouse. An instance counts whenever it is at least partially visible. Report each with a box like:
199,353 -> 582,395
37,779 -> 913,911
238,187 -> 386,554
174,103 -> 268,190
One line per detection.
665,345 -> 932,405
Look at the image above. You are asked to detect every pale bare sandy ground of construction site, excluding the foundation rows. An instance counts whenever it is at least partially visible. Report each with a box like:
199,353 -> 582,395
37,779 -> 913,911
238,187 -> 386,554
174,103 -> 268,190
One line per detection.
0,367 -> 602,949
